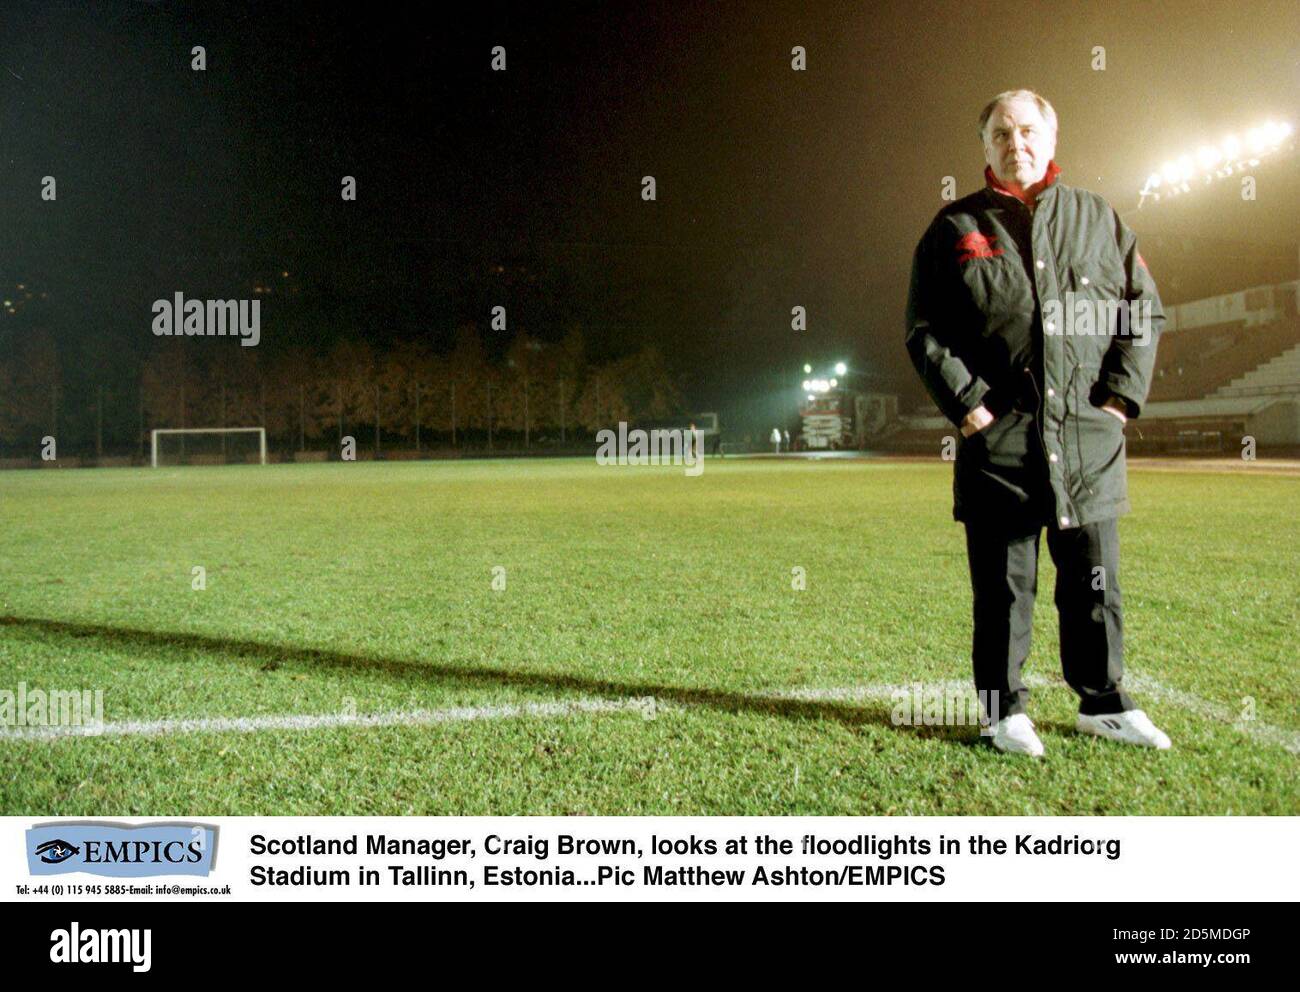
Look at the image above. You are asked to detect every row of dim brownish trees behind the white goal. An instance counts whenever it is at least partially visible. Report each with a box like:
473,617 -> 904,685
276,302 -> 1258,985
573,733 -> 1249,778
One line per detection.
0,325 -> 684,458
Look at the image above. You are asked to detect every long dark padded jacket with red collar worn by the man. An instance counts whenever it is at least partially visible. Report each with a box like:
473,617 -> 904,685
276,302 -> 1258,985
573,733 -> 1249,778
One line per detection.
907,163 -> 1165,528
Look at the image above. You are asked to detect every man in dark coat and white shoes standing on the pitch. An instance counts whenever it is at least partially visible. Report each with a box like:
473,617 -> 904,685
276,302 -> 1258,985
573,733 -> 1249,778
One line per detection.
907,90 -> 1170,755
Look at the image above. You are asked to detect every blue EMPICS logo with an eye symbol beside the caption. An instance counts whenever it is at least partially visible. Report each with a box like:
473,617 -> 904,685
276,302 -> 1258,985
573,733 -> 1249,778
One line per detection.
27,823 -> 217,878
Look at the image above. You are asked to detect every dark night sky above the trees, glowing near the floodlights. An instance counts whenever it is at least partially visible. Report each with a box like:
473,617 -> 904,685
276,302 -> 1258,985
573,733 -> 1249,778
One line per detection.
0,0 -> 1300,413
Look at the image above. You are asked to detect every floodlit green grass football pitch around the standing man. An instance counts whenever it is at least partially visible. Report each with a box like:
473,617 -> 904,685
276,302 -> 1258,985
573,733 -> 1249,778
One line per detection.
0,459 -> 1300,815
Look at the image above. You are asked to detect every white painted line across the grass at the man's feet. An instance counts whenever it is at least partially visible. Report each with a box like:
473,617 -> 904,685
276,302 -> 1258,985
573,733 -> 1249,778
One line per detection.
0,675 -> 1300,754
